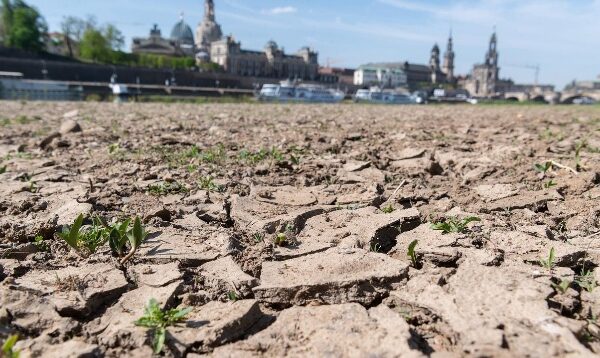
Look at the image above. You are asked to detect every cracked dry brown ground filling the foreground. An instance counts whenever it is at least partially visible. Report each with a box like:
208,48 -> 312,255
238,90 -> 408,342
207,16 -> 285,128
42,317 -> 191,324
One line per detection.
0,102 -> 600,358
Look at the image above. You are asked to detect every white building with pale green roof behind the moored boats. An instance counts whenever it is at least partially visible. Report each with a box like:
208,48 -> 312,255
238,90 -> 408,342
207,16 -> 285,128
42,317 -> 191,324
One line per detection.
354,63 -> 407,88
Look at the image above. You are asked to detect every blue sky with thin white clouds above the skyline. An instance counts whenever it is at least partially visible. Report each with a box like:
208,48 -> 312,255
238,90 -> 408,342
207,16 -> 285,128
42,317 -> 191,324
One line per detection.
28,0 -> 600,88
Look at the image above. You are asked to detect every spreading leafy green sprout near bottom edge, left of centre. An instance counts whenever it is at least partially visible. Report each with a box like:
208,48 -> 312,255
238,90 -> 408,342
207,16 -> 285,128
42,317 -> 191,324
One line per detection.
135,299 -> 192,354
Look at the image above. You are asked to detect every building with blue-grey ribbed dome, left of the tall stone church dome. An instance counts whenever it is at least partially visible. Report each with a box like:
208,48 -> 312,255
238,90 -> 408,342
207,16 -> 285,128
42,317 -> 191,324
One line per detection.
131,15 -> 196,57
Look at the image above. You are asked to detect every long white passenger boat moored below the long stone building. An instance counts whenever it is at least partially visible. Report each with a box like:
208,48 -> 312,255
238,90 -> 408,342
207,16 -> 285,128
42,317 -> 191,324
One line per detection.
258,81 -> 345,103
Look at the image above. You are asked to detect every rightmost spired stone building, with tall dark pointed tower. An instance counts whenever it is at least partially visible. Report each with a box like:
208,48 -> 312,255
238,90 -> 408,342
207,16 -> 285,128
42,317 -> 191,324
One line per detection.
463,32 -> 502,97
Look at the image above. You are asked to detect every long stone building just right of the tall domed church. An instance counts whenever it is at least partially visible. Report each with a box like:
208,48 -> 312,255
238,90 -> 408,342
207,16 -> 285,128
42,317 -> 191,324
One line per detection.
210,36 -> 319,81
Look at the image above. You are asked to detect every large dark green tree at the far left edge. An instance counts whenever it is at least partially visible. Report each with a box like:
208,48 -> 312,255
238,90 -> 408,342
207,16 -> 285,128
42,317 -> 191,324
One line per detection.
2,0 -> 48,52
